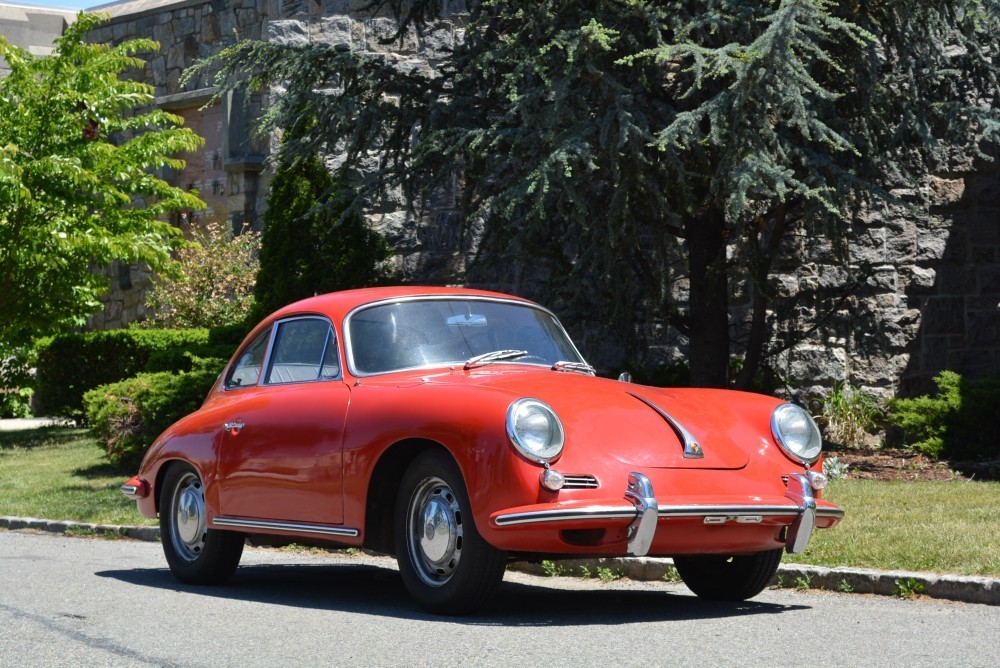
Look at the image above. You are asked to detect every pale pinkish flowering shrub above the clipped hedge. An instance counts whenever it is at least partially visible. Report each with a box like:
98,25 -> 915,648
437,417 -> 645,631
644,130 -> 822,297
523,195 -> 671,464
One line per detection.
146,222 -> 260,328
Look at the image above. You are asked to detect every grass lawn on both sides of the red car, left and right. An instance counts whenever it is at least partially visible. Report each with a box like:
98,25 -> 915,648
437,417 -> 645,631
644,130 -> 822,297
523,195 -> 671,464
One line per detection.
0,427 -> 1000,577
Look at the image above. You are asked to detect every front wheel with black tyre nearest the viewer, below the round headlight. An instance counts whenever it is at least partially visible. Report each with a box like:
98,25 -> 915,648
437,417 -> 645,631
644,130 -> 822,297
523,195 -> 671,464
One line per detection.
395,451 -> 507,615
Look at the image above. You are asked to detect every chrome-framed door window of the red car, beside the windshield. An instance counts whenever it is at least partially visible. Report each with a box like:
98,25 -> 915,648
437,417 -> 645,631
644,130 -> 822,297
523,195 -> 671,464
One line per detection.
265,318 -> 340,384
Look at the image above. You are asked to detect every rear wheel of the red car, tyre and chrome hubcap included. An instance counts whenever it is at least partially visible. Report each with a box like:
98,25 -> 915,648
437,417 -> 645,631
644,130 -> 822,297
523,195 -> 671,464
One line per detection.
160,464 -> 243,584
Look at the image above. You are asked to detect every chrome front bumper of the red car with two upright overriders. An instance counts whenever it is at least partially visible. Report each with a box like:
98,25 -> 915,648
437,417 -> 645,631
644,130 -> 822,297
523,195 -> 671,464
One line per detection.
493,472 -> 844,557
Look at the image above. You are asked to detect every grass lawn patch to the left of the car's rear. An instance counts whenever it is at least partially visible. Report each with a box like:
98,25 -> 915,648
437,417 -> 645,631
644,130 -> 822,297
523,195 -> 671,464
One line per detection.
0,427 -> 156,525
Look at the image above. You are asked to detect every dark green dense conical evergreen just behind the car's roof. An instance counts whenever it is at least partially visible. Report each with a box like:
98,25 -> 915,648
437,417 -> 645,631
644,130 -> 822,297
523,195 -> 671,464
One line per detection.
255,148 -> 390,316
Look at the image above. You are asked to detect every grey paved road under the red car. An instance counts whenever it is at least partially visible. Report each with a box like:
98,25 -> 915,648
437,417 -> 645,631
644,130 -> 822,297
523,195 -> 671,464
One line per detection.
0,531 -> 1000,668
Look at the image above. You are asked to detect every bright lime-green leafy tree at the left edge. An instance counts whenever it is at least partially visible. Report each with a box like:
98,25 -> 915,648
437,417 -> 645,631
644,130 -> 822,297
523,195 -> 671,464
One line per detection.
0,13 -> 204,359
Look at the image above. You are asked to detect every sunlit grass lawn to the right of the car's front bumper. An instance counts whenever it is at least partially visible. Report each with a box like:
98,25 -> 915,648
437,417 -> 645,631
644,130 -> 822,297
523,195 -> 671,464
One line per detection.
784,480 -> 1000,577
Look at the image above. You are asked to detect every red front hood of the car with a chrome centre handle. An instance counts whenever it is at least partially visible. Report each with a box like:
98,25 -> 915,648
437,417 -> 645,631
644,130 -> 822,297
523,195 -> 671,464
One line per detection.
425,366 -> 780,469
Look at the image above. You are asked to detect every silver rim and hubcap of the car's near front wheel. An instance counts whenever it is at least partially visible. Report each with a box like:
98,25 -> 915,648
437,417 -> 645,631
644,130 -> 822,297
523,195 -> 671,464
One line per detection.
407,478 -> 463,587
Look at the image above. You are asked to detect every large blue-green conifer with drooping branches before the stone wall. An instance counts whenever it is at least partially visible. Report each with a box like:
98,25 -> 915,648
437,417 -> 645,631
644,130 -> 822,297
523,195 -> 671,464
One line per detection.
191,0 -> 1000,387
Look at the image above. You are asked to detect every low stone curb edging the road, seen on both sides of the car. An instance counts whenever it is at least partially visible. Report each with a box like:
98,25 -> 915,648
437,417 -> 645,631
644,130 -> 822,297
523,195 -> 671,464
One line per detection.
0,517 -> 1000,605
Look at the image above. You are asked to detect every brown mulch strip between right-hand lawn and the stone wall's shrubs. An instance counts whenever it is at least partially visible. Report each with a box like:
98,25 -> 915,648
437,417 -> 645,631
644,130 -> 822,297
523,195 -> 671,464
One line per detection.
827,448 -> 1000,481
